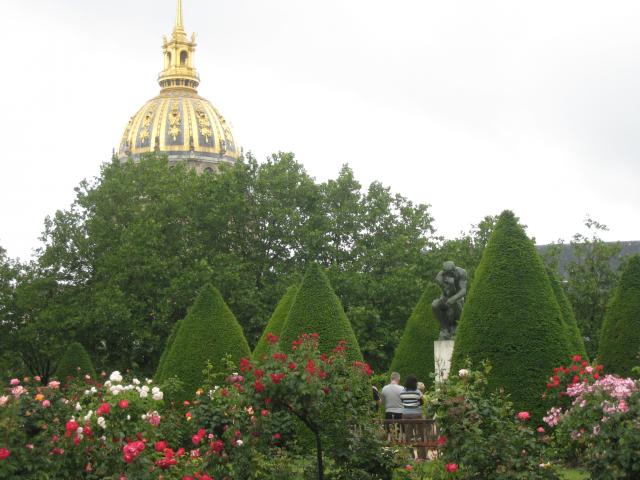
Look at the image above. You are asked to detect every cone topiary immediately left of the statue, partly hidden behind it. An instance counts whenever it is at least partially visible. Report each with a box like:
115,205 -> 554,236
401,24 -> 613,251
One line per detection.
391,283 -> 442,386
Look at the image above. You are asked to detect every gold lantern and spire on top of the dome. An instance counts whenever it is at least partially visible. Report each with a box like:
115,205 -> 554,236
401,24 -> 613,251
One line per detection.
158,0 -> 200,92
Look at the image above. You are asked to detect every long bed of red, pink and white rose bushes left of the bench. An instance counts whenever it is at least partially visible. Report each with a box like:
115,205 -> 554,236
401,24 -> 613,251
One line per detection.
0,335 -> 396,480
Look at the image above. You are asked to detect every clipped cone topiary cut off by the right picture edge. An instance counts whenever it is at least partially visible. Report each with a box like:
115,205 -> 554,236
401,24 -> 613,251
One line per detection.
598,255 -> 640,377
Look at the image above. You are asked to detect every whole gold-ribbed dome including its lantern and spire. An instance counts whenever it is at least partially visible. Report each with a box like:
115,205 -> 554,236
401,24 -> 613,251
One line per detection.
118,0 -> 240,172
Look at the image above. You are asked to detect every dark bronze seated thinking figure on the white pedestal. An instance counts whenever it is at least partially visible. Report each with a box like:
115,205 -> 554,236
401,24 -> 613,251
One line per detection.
431,261 -> 467,340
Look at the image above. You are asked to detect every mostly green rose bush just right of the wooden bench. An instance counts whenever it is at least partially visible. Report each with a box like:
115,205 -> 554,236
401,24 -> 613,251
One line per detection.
424,364 -> 557,480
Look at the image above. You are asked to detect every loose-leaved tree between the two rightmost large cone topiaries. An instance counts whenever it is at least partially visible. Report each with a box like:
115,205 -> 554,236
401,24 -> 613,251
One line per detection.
567,218 -> 620,358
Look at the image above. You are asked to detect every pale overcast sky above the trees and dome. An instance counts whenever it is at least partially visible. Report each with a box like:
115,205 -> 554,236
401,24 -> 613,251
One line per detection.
0,0 -> 640,260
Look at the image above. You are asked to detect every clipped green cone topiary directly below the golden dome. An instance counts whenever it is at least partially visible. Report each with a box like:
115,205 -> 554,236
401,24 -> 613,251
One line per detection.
158,284 -> 251,401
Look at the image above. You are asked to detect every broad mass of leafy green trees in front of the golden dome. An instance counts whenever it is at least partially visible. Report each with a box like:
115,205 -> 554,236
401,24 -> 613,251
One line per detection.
20,153 -> 435,374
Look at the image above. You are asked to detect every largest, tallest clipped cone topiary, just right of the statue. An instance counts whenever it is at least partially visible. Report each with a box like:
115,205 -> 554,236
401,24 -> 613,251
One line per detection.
451,211 -> 570,419
